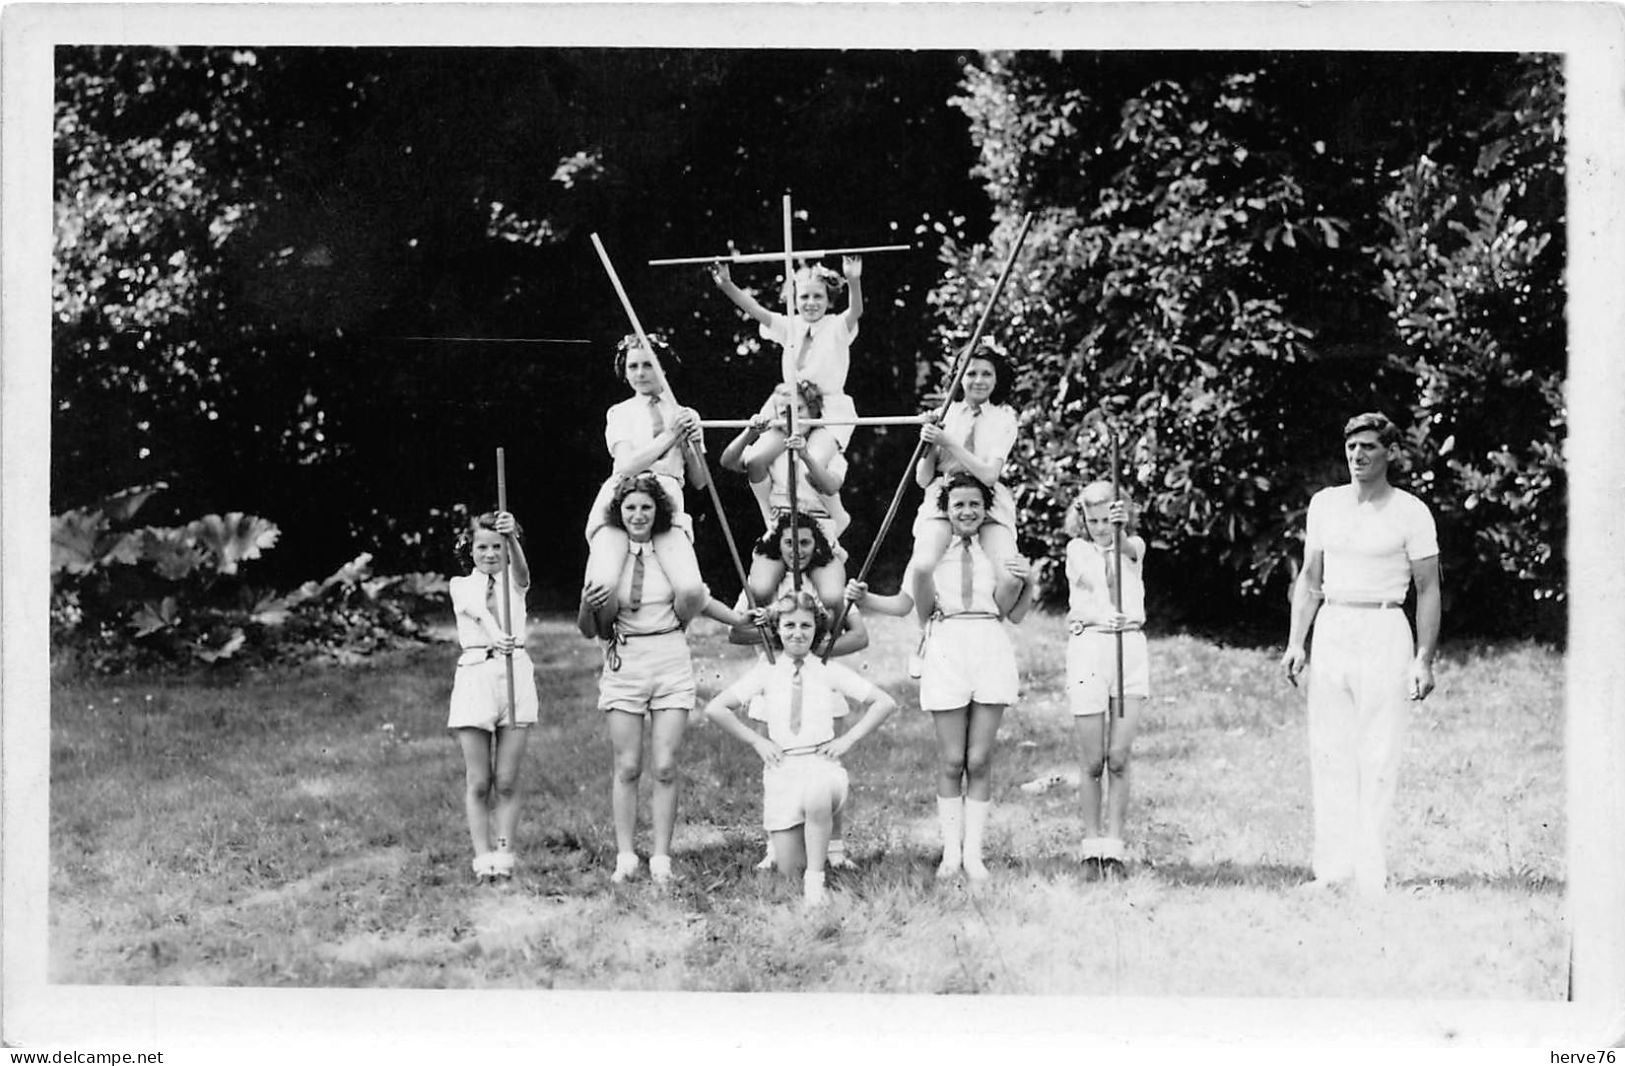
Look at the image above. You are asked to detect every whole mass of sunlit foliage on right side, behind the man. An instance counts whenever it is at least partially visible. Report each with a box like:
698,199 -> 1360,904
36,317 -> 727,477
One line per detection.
933,52 -> 1565,624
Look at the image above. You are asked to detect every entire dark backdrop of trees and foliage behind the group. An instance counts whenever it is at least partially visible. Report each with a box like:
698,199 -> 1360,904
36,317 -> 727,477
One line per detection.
52,47 -> 1567,632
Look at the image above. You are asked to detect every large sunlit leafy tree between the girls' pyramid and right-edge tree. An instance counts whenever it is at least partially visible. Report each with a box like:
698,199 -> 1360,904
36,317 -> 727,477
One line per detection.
933,52 -> 1560,633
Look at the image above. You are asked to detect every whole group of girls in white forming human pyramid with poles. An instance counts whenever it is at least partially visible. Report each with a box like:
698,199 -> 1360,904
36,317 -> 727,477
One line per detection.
449,214 -> 1149,905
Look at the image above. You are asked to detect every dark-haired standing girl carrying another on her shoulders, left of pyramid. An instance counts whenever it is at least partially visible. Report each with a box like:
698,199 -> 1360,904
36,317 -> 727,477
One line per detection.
577,473 -> 752,884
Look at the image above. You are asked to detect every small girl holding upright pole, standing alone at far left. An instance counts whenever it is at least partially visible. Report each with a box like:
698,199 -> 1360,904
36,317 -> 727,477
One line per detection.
445,510 -> 538,881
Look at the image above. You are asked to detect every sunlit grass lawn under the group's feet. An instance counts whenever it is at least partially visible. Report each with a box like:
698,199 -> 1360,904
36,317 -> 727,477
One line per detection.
49,607 -> 1567,1001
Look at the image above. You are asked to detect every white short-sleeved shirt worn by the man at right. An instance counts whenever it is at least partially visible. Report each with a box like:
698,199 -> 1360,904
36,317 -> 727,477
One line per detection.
1303,484 -> 1438,601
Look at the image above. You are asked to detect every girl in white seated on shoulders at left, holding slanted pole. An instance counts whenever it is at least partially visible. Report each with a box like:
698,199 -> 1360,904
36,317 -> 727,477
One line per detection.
585,333 -> 709,634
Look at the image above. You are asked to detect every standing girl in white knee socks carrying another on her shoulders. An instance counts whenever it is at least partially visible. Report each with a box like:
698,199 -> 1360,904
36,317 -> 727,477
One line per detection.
847,471 -> 1032,881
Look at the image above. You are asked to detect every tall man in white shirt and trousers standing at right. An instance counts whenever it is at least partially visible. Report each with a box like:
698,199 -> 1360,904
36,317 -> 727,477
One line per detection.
1281,413 -> 1440,895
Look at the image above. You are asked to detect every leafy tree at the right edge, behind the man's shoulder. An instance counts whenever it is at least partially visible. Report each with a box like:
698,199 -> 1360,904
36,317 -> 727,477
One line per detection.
1375,55 -> 1568,626
